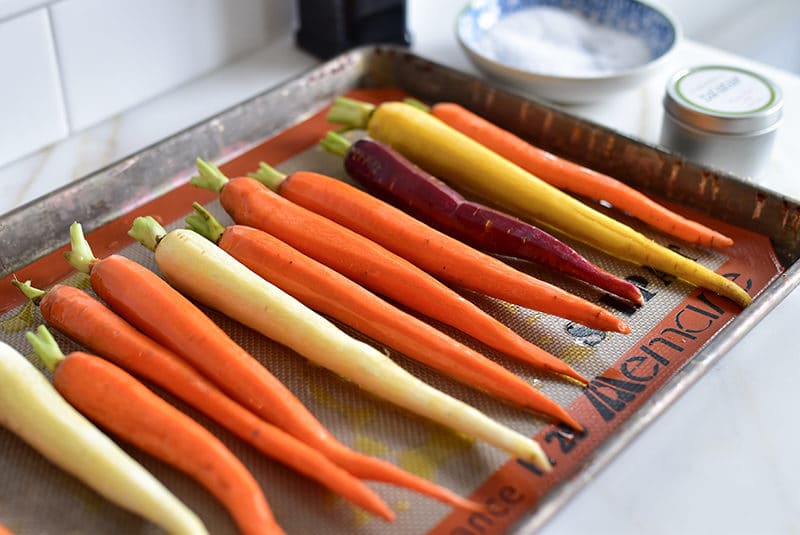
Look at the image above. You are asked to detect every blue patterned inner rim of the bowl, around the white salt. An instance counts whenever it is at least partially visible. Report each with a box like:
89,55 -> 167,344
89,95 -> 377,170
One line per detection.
457,0 -> 678,75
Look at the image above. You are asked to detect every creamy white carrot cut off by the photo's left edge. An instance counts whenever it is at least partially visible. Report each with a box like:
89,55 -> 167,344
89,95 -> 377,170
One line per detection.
0,342 -> 208,535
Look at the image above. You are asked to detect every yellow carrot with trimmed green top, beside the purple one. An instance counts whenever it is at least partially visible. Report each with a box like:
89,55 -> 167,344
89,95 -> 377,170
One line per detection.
328,95 -> 752,307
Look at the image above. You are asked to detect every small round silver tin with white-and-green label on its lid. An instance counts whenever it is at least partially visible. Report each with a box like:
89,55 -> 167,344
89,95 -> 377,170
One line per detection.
661,65 -> 783,179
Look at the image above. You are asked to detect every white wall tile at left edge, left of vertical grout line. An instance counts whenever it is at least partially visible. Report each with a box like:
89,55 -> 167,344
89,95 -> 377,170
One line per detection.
0,9 -> 68,165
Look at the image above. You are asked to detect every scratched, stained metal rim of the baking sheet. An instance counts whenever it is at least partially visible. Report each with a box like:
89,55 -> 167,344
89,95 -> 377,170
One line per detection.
0,46 -> 800,532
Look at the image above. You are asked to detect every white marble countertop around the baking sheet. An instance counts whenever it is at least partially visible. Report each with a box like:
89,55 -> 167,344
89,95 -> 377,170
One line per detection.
0,0 -> 800,535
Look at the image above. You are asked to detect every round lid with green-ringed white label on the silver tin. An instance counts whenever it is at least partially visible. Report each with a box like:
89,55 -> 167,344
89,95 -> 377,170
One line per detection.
664,65 -> 783,134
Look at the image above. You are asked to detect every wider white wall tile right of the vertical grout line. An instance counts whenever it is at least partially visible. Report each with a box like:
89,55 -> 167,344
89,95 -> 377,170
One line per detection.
50,0 -> 292,129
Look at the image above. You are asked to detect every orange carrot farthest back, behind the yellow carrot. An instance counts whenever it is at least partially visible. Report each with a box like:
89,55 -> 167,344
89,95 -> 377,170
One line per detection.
430,102 -> 733,247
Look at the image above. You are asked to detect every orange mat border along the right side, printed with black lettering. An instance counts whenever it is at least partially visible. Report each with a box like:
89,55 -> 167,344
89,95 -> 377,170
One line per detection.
428,211 -> 783,535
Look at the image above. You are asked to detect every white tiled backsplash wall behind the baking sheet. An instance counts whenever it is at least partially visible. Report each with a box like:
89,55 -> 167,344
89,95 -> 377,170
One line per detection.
0,0 -> 296,166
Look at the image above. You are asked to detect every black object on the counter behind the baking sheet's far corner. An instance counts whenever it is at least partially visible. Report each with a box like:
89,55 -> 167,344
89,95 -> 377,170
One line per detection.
296,0 -> 411,59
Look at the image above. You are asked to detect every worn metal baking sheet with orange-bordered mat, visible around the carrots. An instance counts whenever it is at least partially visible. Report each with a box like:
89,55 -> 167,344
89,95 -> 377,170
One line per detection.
0,46 -> 800,534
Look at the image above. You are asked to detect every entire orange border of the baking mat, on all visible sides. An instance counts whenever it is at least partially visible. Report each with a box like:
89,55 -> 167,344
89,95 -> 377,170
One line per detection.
0,89 -> 782,535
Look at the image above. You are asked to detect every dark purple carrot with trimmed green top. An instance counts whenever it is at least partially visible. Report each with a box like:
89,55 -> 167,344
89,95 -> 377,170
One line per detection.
318,132 -> 643,305
